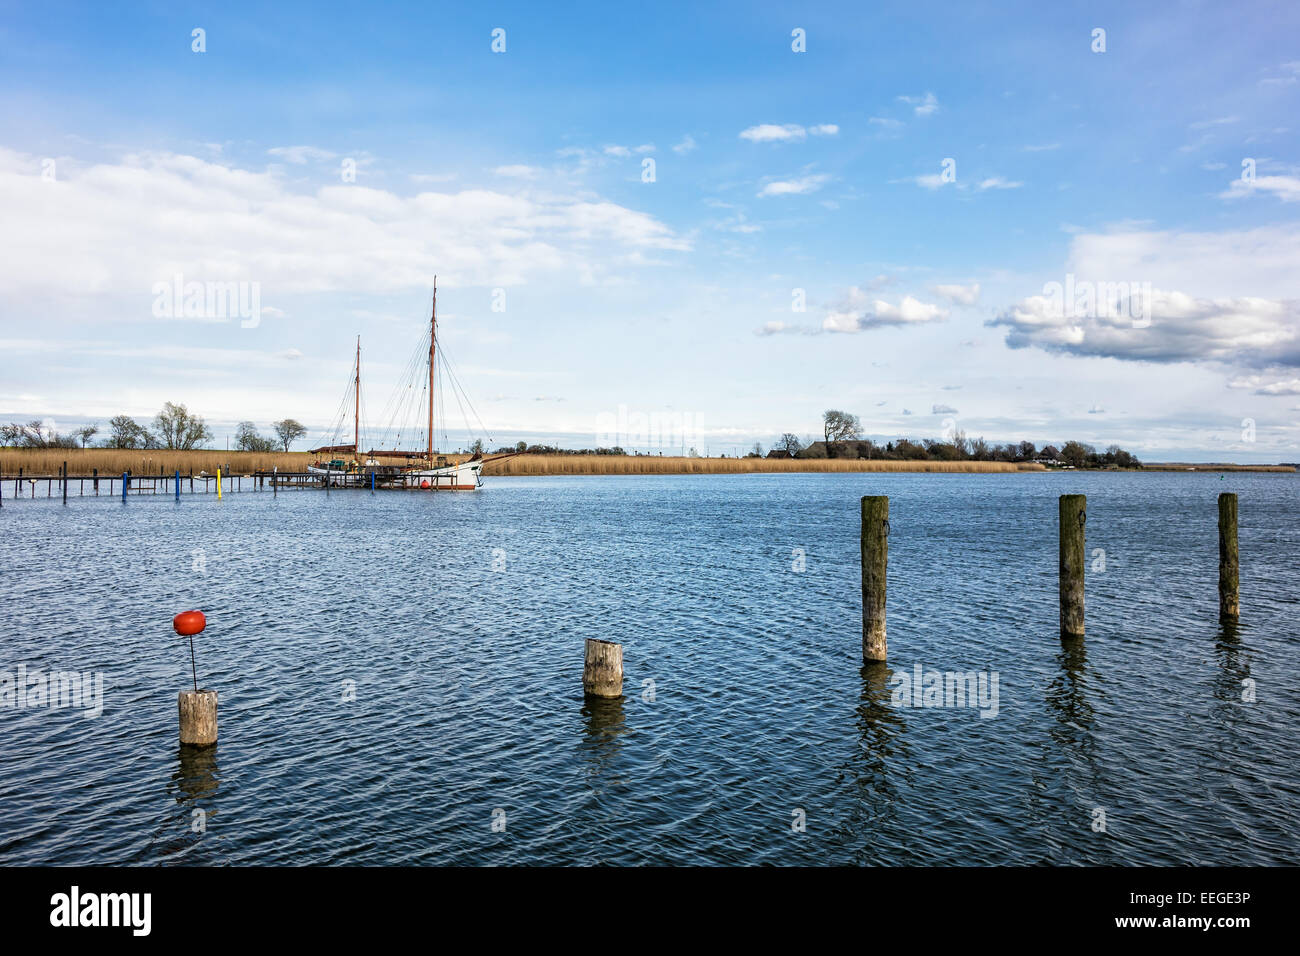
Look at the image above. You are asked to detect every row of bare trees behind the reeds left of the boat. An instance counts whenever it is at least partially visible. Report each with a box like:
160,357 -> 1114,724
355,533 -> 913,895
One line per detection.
0,402 -> 307,451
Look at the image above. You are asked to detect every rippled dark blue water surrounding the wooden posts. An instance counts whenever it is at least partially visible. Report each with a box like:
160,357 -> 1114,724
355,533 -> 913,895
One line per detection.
0,473 -> 1300,865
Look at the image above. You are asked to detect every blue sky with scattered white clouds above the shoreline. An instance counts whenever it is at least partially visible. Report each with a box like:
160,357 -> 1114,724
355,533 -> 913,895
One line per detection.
0,0 -> 1300,462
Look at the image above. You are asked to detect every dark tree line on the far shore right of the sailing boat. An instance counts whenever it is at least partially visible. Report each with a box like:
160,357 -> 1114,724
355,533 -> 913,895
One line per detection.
750,408 -> 1141,468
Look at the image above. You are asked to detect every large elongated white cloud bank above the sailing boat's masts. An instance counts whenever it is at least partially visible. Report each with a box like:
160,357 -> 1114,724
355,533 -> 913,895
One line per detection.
0,150 -> 690,304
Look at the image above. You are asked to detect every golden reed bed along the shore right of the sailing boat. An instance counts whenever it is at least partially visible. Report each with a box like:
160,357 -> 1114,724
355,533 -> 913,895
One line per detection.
484,455 -> 1044,475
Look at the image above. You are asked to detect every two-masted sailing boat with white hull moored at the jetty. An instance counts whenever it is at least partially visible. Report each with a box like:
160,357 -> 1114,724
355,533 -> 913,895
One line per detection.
308,278 -> 501,492
